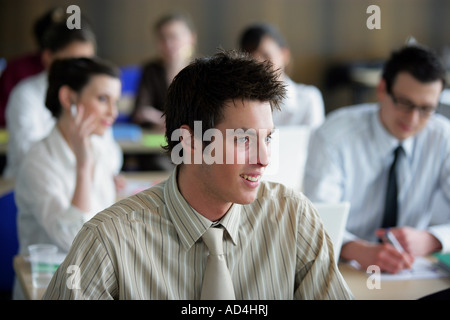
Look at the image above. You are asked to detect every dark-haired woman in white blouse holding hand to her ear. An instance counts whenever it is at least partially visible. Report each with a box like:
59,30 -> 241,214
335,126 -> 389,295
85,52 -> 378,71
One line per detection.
15,58 -> 121,300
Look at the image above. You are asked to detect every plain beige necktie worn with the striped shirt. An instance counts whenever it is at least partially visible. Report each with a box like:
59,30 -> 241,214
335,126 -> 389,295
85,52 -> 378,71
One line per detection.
200,228 -> 236,300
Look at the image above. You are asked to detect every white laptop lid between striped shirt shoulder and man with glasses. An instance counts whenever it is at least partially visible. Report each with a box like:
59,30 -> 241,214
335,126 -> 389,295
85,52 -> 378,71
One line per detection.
313,202 -> 350,262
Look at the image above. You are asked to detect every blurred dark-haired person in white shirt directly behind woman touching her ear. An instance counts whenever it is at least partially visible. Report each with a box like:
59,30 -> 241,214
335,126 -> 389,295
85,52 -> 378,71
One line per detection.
3,18 -> 123,179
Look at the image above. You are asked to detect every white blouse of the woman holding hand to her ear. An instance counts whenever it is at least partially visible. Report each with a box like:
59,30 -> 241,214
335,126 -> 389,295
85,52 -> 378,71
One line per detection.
15,126 -> 117,254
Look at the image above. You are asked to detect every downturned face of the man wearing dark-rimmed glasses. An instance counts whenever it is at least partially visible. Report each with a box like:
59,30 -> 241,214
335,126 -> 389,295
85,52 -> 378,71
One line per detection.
378,72 -> 442,140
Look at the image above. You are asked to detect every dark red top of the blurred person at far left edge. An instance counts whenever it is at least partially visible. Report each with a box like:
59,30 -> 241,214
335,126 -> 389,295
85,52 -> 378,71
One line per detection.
0,53 -> 44,128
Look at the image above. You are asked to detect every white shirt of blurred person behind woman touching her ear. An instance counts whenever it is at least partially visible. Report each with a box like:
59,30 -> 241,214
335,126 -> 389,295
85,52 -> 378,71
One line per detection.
3,71 -> 123,178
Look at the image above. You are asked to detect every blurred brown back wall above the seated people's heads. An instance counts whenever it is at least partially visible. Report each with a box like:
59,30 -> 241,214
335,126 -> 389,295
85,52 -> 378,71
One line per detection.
0,0 -> 450,112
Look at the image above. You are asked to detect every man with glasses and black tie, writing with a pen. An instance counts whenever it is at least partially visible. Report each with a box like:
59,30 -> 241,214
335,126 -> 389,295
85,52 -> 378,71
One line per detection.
304,46 -> 450,273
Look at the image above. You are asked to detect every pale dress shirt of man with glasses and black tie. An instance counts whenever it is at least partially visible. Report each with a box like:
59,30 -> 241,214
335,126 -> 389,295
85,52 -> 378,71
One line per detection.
304,104 -> 450,252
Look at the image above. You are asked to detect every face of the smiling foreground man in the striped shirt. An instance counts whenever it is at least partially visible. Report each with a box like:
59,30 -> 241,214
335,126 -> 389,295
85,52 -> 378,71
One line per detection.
196,100 -> 273,205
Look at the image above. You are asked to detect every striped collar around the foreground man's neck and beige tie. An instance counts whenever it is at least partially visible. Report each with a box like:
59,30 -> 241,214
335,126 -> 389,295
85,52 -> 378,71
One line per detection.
164,167 -> 241,250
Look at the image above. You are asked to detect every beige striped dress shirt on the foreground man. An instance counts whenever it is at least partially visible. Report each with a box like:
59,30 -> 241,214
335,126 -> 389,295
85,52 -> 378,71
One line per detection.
43,168 -> 353,300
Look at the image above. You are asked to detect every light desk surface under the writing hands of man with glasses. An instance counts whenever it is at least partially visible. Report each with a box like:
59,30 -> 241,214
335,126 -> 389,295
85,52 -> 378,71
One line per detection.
339,262 -> 450,300
